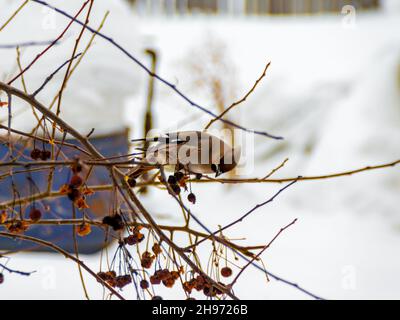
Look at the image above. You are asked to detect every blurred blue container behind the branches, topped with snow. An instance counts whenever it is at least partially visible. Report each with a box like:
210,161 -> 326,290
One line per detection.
0,131 -> 129,254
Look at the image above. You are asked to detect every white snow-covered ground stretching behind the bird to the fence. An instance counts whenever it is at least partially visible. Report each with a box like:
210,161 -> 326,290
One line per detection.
0,0 -> 400,299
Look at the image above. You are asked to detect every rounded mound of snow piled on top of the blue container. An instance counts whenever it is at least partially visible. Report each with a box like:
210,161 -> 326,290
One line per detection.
0,0 -> 141,135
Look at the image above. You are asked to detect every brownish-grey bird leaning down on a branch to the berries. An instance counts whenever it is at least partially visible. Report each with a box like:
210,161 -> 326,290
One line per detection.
128,131 -> 241,178
